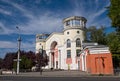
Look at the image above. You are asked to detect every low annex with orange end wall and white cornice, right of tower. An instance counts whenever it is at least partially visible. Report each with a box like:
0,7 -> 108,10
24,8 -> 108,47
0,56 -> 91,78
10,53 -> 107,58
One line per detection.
80,43 -> 113,75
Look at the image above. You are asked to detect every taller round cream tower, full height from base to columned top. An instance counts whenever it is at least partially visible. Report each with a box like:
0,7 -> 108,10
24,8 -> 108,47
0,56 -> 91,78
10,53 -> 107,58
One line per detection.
63,16 -> 87,70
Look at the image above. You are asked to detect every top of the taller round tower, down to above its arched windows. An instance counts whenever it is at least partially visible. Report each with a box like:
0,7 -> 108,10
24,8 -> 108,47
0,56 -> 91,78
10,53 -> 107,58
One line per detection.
63,16 -> 87,42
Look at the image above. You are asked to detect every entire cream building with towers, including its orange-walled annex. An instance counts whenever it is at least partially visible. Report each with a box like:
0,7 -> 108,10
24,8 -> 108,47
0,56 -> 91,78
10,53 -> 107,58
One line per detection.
36,16 -> 113,74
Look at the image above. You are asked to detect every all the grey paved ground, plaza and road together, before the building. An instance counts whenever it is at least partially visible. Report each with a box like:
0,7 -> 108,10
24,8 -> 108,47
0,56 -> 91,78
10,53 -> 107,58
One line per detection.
0,71 -> 120,81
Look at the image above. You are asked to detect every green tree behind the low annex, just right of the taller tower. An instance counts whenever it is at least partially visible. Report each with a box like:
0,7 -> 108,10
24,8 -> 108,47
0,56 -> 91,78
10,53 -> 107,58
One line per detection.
87,26 -> 106,44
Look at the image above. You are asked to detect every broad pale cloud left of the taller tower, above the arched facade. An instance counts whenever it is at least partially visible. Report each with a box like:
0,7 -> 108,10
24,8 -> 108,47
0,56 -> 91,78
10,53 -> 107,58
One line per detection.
20,14 -> 62,34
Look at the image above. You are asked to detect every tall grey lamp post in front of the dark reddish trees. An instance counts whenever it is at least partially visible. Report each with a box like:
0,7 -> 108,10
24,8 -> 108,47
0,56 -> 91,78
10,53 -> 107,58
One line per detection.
16,27 -> 21,74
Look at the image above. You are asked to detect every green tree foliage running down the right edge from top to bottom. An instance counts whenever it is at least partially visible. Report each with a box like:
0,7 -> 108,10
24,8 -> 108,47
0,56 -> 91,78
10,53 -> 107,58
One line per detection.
107,0 -> 120,67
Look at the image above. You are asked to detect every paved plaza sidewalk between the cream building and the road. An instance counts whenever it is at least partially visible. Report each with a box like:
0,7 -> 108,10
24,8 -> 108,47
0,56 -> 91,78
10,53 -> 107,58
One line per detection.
1,71 -> 90,77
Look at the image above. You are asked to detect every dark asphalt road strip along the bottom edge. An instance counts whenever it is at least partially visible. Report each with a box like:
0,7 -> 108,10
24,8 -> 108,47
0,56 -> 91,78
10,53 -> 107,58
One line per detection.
0,76 -> 120,81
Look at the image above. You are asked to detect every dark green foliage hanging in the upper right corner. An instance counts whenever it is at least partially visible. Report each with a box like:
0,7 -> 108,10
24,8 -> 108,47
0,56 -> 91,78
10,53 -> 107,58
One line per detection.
108,0 -> 120,35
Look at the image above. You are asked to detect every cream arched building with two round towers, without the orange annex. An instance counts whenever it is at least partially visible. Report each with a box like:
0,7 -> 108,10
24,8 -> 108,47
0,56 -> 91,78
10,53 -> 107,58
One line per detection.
36,16 -> 87,70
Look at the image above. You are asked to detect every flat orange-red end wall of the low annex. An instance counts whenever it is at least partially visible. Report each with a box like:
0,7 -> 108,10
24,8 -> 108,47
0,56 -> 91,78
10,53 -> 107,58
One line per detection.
86,54 -> 113,74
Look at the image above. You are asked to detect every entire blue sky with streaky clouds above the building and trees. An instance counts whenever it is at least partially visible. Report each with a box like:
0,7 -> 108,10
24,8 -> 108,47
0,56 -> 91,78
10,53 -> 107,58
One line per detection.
0,0 -> 114,57
